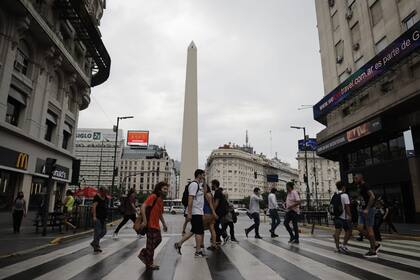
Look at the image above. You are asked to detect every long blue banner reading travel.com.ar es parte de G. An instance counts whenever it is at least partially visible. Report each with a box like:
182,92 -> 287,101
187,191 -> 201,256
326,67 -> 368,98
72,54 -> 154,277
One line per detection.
313,21 -> 420,124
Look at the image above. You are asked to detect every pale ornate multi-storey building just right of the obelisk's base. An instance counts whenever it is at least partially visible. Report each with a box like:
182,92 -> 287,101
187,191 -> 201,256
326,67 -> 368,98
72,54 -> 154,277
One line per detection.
206,144 -> 298,202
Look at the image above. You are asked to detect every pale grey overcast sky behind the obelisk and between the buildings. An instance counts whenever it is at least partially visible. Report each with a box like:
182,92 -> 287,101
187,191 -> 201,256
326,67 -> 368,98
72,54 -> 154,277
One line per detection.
79,0 -> 323,166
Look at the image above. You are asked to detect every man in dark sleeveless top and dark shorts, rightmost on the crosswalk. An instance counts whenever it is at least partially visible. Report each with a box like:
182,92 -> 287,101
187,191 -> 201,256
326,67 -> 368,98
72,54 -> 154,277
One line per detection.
354,173 -> 381,258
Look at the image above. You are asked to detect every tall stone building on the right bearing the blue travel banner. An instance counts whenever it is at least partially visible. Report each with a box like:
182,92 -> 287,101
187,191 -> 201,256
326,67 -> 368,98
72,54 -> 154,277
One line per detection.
313,0 -> 420,223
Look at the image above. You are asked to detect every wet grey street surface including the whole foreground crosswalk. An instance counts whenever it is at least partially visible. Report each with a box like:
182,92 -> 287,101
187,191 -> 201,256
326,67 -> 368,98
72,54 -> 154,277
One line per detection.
0,215 -> 420,280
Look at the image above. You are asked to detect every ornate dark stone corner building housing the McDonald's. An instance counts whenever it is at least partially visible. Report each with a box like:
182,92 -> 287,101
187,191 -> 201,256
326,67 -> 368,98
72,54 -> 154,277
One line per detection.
0,0 -> 111,210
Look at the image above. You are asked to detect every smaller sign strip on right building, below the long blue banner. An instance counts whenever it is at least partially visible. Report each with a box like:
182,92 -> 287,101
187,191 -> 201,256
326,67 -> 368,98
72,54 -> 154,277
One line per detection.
316,119 -> 382,155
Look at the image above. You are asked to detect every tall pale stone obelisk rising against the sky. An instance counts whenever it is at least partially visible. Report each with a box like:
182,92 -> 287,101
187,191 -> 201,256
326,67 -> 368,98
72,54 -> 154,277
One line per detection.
179,41 -> 198,198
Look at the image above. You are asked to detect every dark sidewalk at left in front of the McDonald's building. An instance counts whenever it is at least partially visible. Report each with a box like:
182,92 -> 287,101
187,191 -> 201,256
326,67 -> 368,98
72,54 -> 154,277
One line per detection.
0,212 -> 120,259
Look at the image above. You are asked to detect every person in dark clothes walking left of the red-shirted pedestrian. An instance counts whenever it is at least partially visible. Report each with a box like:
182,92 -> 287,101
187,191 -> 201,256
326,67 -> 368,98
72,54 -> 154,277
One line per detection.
90,187 -> 108,253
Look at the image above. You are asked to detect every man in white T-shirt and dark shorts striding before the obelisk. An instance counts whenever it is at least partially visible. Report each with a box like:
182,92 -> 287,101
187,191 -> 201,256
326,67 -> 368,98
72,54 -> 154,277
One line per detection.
174,169 -> 206,258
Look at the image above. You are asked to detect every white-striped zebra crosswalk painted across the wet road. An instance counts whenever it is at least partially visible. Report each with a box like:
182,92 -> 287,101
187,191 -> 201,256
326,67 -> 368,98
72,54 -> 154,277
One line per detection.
0,235 -> 420,280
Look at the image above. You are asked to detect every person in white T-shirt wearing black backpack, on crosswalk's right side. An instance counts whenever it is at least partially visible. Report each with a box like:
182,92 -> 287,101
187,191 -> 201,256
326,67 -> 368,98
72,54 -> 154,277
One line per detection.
330,181 -> 353,254
